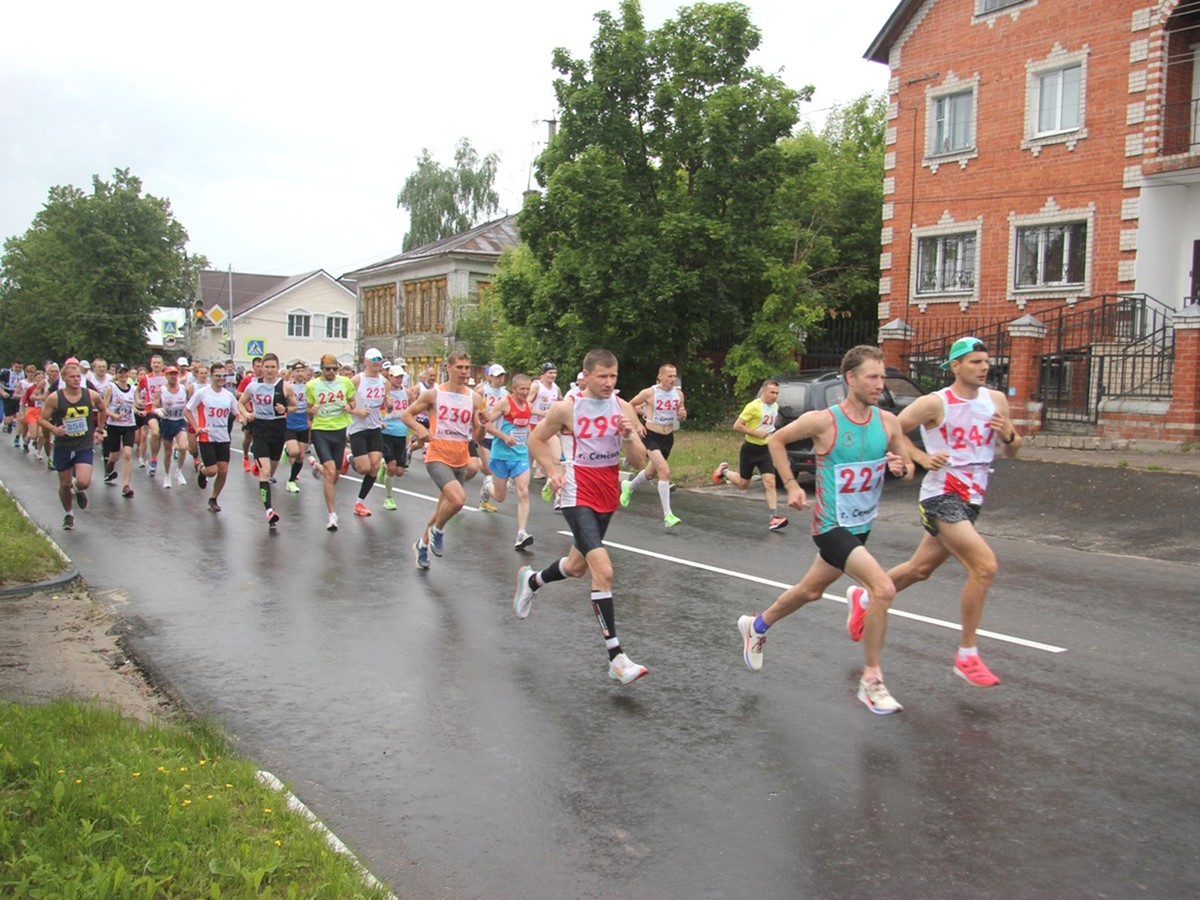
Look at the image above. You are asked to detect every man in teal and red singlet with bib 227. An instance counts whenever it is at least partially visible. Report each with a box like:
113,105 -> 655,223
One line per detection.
738,344 -> 912,715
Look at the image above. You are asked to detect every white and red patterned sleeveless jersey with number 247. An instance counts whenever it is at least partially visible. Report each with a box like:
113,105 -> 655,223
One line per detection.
920,388 -> 996,506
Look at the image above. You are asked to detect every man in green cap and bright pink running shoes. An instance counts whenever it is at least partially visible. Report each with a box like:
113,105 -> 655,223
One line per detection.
864,337 -> 1021,688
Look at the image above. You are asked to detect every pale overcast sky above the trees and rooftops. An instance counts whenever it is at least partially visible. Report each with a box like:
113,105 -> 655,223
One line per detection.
0,0 -> 896,276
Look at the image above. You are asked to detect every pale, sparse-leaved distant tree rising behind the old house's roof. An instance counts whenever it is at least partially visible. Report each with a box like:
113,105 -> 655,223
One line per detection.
396,138 -> 500,251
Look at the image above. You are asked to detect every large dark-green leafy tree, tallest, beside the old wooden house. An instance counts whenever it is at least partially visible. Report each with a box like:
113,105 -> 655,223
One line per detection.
497,0 -> 812,406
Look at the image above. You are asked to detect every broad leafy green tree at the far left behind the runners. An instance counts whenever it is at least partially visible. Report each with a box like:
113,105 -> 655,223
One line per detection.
0,169 -> 206,361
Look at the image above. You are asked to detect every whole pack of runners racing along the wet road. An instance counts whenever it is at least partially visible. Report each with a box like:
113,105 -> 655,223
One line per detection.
0,337 -> 1021,714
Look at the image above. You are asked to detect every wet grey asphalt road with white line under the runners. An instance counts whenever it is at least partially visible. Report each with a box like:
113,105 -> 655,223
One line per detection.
0,446 -> 1200,898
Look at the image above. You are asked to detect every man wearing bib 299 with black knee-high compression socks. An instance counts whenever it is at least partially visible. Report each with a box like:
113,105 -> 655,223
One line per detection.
512,349 -> 648,684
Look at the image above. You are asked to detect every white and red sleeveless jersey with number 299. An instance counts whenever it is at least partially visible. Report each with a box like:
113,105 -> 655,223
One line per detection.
560,395 -> 622,512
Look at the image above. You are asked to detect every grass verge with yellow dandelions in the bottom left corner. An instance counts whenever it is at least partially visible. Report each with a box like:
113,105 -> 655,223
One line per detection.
0,701 -> 389,898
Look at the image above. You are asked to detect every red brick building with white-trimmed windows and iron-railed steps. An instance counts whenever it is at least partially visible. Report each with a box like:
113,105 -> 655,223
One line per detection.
865,0 -> 1200,440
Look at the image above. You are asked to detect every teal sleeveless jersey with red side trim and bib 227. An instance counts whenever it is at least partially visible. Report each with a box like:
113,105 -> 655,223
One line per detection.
812,404 -> 888,534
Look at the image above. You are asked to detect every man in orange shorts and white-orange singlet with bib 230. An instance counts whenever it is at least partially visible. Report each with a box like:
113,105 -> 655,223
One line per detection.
401,350 -> 484,569
